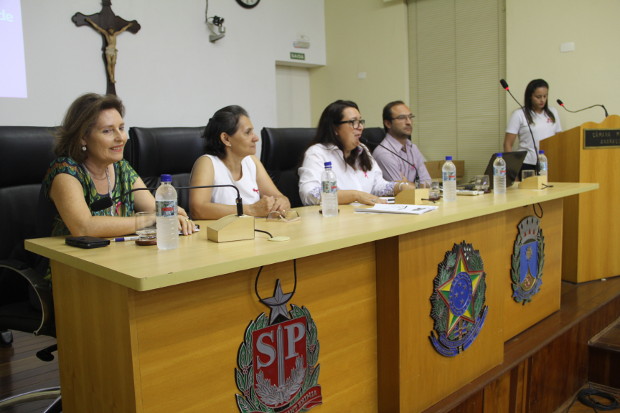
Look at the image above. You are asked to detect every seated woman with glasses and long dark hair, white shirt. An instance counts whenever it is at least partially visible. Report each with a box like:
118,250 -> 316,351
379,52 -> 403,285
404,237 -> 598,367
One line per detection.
299,100 -> 410,205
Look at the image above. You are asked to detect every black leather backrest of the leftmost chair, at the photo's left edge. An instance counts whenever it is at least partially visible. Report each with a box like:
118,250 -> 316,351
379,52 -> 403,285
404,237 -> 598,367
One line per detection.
0,126 -> 55,332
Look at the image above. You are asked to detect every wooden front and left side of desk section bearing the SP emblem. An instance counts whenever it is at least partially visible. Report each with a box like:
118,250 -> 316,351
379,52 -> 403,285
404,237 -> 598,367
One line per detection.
54,243 -> 377,413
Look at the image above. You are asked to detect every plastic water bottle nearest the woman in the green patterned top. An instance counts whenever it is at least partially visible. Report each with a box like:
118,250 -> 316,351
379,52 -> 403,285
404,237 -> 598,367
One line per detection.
155,174 -> 179,250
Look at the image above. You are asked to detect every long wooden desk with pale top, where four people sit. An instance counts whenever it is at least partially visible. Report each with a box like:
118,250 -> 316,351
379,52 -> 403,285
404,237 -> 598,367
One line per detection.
26,183 -> 597,413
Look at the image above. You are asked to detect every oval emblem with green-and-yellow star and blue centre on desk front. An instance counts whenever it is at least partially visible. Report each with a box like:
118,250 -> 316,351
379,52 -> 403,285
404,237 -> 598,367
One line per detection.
429,241 -> 488,357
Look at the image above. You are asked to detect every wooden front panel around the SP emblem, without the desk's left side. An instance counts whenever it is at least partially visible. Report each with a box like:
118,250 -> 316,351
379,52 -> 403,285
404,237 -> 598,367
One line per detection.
131,244 -> 377,412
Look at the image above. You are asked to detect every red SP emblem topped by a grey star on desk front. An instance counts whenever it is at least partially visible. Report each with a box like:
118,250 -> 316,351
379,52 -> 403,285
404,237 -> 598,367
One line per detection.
235,280 -> 322,413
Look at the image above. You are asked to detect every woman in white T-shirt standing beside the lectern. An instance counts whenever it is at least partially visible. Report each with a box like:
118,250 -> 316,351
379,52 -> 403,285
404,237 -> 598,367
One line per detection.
504,79 -> 562,170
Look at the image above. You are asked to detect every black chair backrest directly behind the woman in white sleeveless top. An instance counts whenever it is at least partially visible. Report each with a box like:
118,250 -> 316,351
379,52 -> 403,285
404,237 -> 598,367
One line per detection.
125,127 -> 205,213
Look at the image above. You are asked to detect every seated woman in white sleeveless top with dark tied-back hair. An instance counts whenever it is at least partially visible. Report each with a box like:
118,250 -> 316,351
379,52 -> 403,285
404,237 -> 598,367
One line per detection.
189,105 -> 291,219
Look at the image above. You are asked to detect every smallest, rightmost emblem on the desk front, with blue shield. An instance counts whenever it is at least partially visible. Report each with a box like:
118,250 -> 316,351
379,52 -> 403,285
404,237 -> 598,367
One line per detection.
510,216 -> 545,305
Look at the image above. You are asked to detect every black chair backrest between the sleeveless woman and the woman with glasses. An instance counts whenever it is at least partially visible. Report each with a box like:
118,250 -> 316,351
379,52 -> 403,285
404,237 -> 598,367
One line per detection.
260,128 -> 316,208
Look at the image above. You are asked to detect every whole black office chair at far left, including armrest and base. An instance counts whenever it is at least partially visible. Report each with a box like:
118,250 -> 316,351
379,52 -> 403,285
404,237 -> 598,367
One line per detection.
0,126 -> 61,413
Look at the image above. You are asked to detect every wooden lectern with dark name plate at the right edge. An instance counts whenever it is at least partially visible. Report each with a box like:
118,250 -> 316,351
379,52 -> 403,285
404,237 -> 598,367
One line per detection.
540,115 -> 620,283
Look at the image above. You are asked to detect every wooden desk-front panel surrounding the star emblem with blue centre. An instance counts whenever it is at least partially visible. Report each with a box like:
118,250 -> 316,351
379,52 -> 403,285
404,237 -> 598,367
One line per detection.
377,213 -> 504,411
